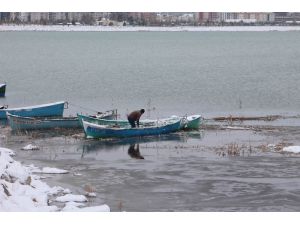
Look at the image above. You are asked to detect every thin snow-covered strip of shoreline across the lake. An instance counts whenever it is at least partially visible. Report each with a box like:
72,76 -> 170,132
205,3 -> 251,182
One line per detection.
0,24 -> 300,32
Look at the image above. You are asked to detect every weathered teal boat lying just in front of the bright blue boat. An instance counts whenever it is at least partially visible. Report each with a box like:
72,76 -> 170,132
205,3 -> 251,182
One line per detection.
7,113 -> 81,131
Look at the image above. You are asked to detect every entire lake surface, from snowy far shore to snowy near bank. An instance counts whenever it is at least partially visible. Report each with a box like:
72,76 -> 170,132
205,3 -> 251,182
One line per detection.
0,32 -> 300,211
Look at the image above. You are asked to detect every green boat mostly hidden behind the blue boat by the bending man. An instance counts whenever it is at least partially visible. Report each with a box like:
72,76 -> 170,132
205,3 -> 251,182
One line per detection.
77,114 -> 202,129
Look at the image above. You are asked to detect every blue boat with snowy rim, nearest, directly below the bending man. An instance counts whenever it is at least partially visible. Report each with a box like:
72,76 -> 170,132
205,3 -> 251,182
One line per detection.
82,120 -> 181,138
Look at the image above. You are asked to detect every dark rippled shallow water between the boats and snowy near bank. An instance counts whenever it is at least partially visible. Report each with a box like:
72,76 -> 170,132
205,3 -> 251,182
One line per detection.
1,123 -> 300,211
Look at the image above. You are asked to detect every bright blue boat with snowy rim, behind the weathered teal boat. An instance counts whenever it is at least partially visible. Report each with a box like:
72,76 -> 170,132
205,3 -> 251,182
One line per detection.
0,101 -> 67,119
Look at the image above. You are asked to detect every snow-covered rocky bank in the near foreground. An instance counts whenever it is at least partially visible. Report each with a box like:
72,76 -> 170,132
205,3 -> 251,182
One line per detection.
0,148 -> 110,212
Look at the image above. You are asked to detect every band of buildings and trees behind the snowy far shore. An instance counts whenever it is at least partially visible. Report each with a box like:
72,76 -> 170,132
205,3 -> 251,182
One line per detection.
0,12 -> 300,26
